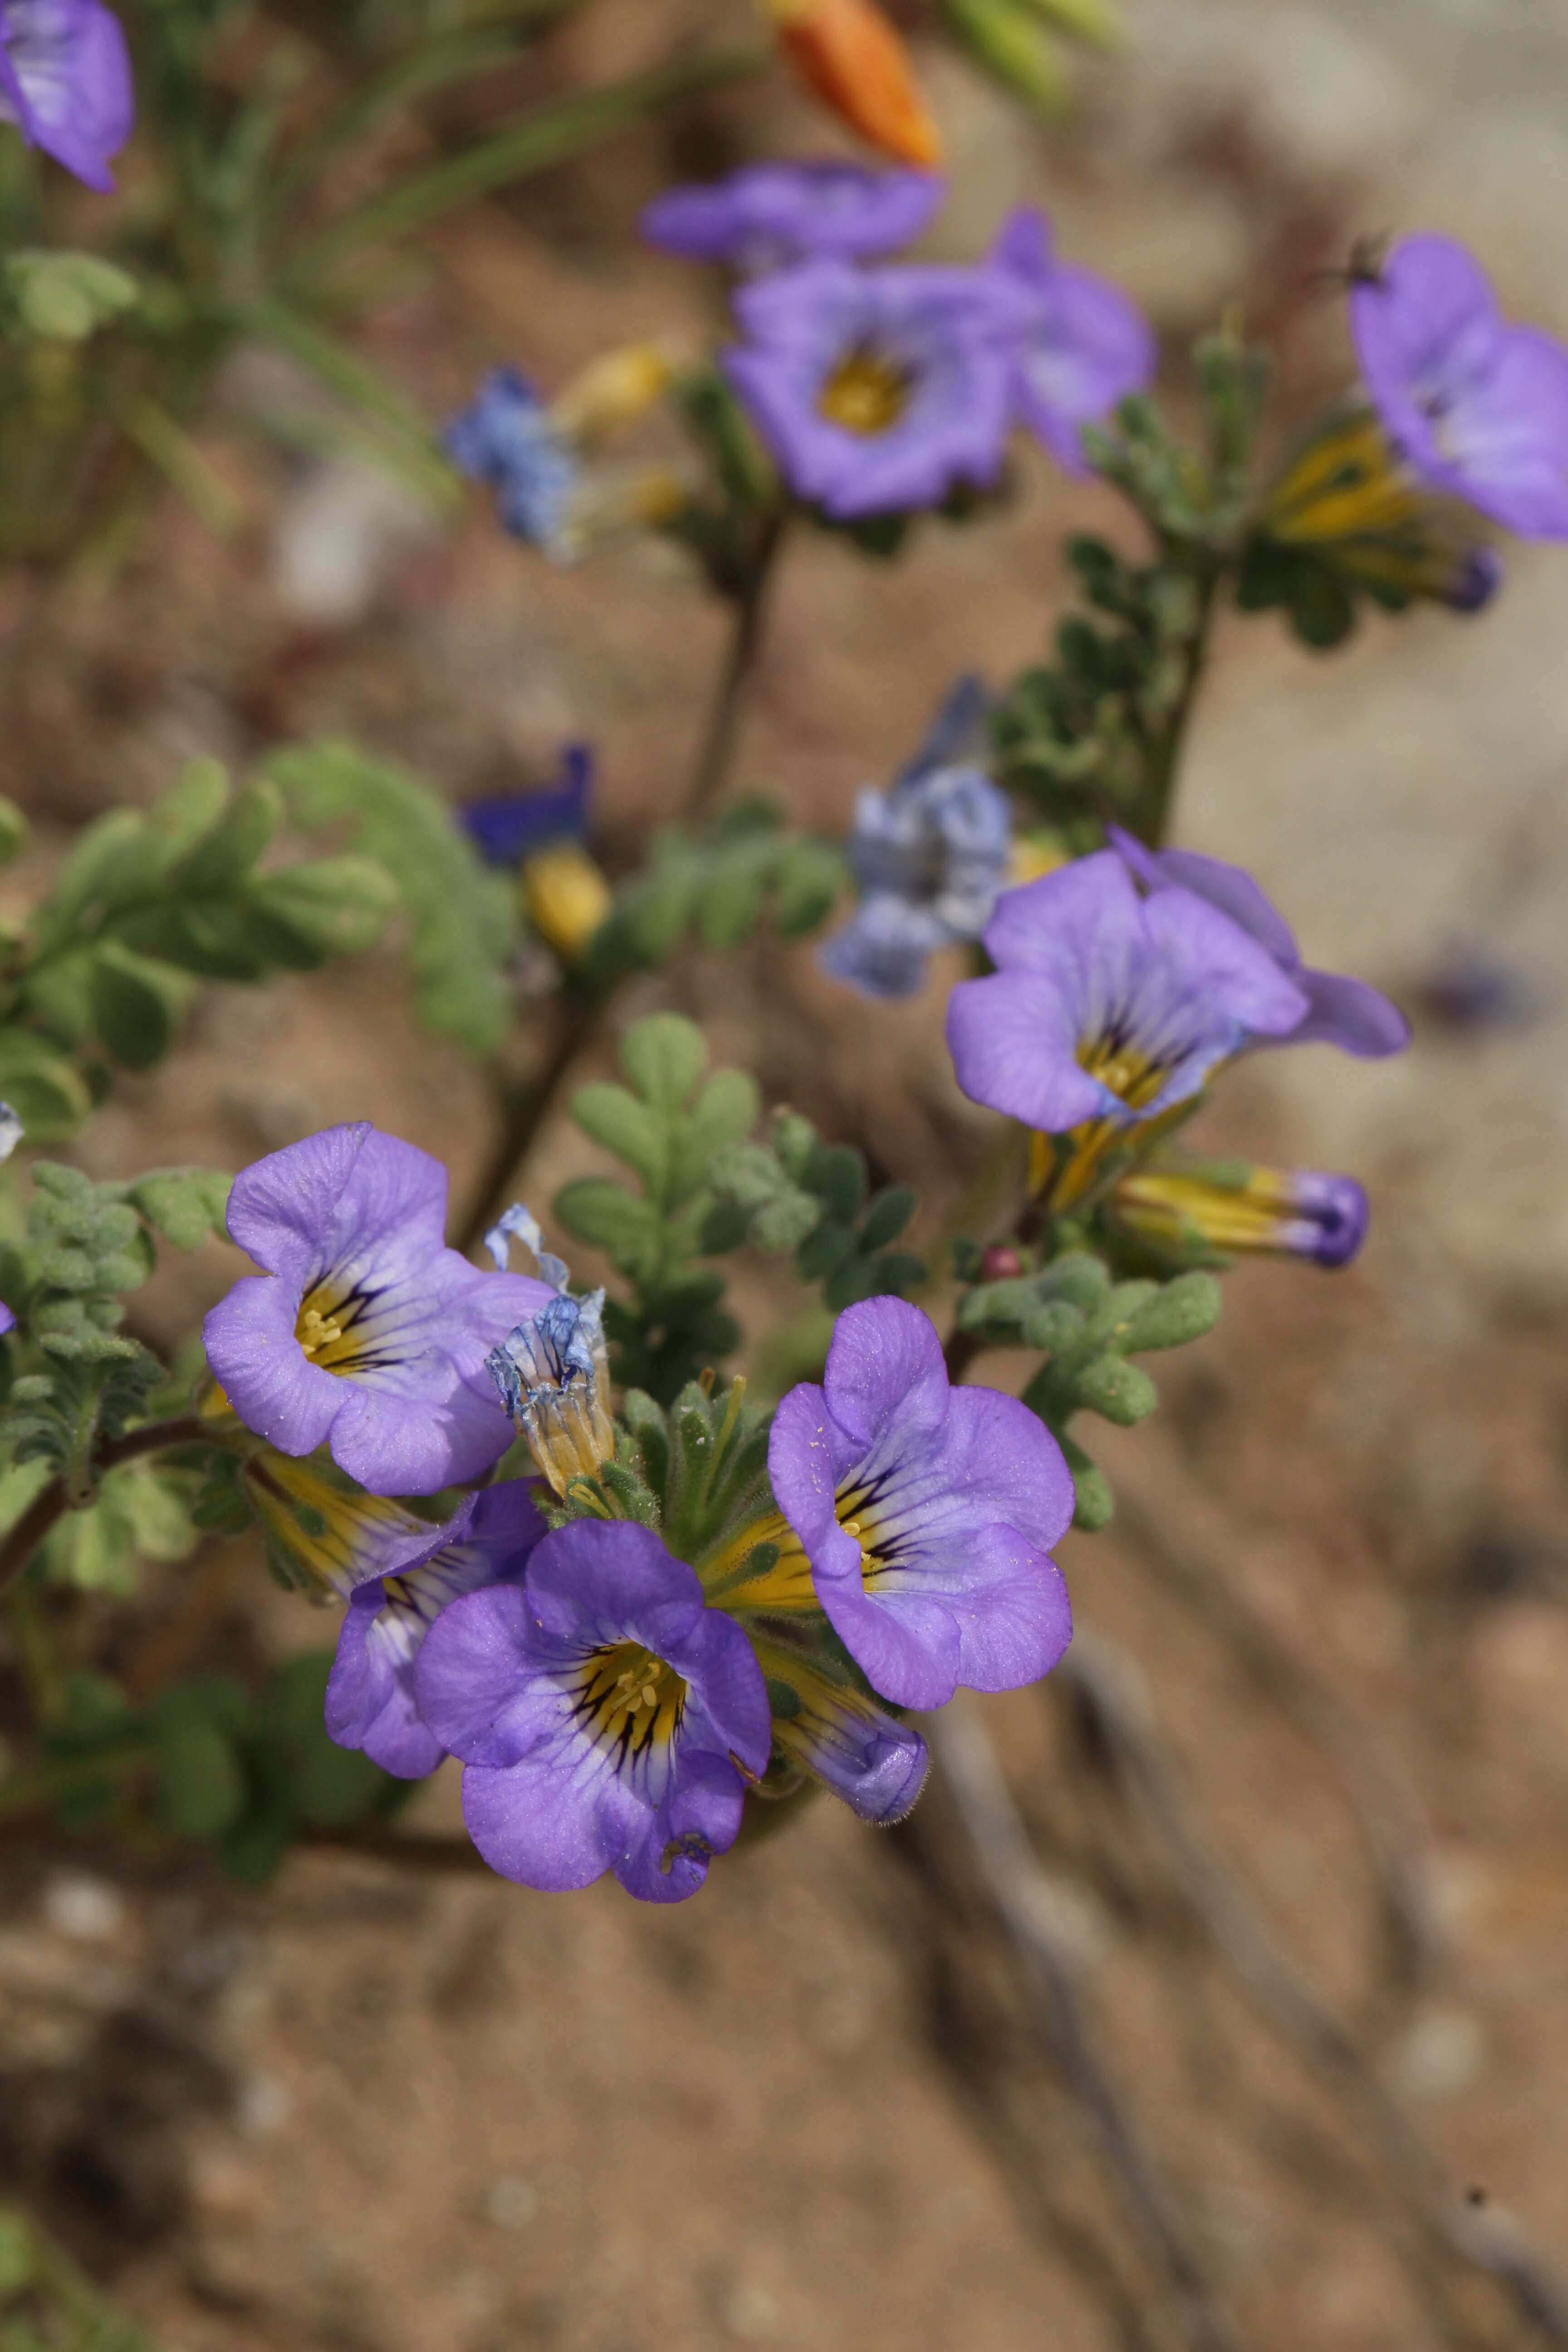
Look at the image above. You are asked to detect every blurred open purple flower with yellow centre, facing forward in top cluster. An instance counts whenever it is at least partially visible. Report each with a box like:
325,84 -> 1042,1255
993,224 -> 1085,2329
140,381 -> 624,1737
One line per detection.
724,259 -> 1027,520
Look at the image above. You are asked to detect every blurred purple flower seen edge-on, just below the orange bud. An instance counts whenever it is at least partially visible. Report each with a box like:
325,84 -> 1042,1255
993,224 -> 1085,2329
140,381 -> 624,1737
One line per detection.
639,162 -> 945,278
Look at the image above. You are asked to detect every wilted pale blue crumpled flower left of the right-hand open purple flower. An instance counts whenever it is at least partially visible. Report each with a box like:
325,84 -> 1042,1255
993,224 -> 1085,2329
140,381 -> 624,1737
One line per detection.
818,677 -> 1013,997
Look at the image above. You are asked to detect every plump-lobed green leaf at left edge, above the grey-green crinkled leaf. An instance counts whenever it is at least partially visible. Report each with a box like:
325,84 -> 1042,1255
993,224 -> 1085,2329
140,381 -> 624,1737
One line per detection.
0,760 -> 397,1141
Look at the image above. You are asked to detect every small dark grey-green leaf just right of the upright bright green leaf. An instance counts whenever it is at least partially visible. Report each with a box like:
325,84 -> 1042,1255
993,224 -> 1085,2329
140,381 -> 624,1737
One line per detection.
710,1110 -> 926,1313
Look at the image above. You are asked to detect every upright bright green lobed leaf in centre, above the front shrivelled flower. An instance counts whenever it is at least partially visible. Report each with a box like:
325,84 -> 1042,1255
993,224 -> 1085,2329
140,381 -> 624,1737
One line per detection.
555,1014 -> 760,1402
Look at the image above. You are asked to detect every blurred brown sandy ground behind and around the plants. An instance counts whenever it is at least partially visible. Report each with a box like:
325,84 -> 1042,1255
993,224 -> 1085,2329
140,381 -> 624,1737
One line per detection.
0,0 -> 1568,2352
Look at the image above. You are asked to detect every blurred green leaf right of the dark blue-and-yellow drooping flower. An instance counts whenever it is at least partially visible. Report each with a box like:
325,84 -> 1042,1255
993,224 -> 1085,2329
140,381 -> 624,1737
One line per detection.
590,800 -> 844,979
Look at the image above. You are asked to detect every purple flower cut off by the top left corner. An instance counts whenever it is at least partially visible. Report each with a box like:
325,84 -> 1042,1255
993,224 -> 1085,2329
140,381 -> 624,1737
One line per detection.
0,0 -> 137,191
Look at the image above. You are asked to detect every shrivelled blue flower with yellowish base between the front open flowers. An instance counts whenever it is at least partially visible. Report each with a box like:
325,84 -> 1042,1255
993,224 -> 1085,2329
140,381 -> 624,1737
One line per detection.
484,1204 -> 616,1494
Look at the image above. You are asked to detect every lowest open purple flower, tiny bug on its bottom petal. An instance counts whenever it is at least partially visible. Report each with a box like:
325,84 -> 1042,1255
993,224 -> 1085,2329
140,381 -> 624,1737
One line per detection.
414,1519 -> 769,1903
